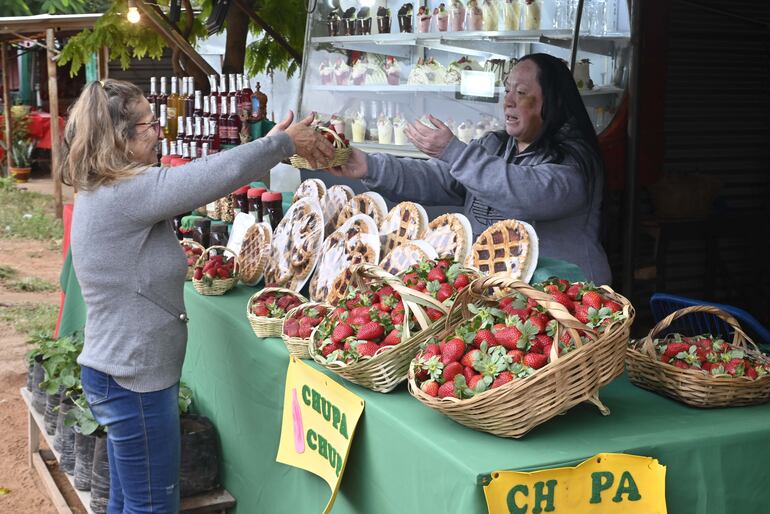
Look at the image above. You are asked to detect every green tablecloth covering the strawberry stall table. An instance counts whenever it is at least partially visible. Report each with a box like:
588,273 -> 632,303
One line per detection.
62,254 -> 770,514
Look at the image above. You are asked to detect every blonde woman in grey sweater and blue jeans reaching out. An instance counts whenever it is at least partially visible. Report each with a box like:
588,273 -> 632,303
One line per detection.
61,80 -> 334,513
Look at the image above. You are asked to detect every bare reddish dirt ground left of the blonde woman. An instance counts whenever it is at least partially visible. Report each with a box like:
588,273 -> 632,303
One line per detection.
0,239 -> 62,514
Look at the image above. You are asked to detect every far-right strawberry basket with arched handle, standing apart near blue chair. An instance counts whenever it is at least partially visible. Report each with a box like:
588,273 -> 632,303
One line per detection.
626,305 -> 770,408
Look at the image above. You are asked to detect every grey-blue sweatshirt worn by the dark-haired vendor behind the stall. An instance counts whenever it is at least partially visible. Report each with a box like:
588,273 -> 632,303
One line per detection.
363,125 -> 611,284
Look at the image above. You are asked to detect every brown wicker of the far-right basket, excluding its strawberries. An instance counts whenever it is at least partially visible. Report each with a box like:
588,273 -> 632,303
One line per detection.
626,305 -> 770,408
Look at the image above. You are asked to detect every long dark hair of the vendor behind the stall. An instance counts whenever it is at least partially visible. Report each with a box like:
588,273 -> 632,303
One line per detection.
519,54 -> 600,156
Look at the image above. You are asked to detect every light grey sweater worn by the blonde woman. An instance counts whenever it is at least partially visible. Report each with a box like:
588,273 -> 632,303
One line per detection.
71,134 -> 294,392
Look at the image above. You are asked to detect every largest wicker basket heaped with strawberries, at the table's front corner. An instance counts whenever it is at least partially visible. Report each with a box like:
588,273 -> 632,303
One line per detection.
408,274 -> 630,438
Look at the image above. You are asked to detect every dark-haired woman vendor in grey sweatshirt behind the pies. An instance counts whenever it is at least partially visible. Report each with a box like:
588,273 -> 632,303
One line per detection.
331,54 -> 611,284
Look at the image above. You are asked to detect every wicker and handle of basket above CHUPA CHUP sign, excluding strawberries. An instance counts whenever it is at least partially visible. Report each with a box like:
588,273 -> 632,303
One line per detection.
308,264 -> 447,393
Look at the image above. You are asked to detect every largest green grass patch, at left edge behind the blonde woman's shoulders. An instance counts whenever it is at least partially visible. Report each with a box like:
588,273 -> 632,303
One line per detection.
0,179 -> 63,241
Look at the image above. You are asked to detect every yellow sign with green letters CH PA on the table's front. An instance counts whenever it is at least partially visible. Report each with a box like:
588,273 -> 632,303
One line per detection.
484,453 -> 666,514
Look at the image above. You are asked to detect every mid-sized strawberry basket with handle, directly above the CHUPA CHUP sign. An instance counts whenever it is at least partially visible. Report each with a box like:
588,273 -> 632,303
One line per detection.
308,264 -> 448,393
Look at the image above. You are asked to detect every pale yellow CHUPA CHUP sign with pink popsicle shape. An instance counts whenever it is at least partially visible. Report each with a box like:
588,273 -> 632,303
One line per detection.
275,357 -> 364,514
